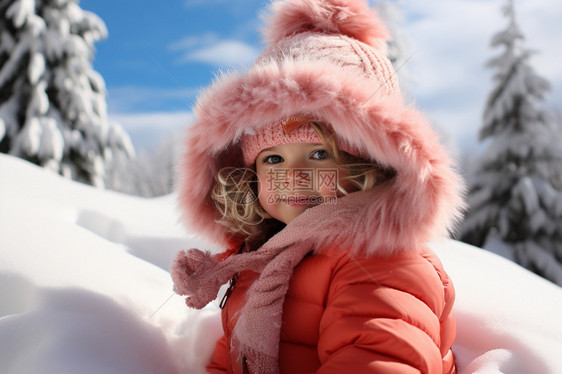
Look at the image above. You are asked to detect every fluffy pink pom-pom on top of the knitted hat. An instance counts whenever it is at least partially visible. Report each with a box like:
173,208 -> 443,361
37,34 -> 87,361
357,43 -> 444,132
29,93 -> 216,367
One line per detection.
264,0 -> 388,52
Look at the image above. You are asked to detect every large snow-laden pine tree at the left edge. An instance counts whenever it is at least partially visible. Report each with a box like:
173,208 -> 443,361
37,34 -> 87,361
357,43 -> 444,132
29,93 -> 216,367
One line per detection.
0,0 -> 134,186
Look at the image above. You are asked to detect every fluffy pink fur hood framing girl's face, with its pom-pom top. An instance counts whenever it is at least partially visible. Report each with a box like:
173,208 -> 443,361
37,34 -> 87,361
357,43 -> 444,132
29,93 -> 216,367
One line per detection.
179,0 -> 464,254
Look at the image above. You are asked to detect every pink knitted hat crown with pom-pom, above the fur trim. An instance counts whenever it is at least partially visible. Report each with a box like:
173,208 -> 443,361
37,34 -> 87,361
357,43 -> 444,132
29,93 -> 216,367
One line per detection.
255,0 -> 399,95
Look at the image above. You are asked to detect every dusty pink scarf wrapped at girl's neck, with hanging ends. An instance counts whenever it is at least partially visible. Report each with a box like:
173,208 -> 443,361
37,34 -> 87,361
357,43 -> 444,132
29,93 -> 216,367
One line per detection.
170,193 -> 376,373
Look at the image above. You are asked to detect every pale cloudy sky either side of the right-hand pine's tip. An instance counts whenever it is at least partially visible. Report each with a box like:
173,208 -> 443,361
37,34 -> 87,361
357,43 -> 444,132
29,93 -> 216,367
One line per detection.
401,0 -> 562,157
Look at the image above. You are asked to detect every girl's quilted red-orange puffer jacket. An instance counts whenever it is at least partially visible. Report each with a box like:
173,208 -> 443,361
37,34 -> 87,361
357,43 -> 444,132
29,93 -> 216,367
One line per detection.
207,244 -> 455,374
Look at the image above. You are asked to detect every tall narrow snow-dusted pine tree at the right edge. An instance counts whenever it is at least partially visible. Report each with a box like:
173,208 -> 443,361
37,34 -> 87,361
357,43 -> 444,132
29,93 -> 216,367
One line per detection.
461,0 -> 562,285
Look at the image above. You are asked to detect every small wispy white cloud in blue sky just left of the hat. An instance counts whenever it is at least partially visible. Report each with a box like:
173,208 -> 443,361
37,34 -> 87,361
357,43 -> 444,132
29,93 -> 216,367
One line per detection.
169,33 -> 260,66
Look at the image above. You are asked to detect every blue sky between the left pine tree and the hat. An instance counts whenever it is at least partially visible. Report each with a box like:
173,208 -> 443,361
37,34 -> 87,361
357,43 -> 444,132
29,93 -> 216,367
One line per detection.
80,0 -> 263,113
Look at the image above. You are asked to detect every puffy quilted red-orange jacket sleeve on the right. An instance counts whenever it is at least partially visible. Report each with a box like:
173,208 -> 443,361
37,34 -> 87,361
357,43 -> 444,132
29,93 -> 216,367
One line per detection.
318,254 -> 444,374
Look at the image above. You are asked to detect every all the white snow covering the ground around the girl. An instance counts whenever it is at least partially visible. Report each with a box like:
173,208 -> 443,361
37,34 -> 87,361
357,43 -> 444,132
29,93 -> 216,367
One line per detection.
0,155 -> 562,374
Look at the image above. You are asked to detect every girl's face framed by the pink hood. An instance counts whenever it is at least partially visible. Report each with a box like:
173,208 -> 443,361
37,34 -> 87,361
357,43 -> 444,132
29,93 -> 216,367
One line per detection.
256,143 -> 347,224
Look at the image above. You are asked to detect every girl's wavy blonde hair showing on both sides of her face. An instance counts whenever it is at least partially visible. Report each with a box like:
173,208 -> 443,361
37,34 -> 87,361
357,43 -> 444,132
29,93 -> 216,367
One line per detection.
211,121 -> 391,243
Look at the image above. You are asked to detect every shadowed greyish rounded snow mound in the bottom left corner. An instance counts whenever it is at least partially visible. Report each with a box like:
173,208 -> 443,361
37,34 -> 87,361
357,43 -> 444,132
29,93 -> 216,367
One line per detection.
0,289 -> 177,374
